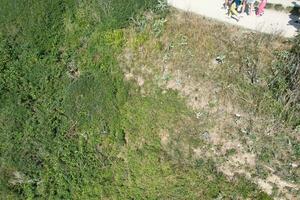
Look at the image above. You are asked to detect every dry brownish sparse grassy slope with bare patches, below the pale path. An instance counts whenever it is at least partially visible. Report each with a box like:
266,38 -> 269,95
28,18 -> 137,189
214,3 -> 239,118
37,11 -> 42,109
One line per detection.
119,9 -> 300,199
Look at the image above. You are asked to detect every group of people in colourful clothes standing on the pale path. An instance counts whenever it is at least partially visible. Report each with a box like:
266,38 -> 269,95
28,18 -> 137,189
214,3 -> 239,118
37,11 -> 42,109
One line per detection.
224,0 -> 267,21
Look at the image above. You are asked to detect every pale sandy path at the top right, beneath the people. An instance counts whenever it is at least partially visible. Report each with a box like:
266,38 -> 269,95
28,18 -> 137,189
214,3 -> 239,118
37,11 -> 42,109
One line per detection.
168,0 -> 300,37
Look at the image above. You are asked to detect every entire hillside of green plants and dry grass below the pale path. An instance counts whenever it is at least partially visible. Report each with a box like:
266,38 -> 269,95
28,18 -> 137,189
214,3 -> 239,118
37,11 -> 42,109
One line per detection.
0,0 -> 300,199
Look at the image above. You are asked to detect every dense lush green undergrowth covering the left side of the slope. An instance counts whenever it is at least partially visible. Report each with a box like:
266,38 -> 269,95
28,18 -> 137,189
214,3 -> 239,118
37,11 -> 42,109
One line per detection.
0,0 -> 294,199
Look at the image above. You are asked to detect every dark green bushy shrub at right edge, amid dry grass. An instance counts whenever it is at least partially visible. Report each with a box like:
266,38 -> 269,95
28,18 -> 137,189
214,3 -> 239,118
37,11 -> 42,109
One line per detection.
268,35 -> 300,127
